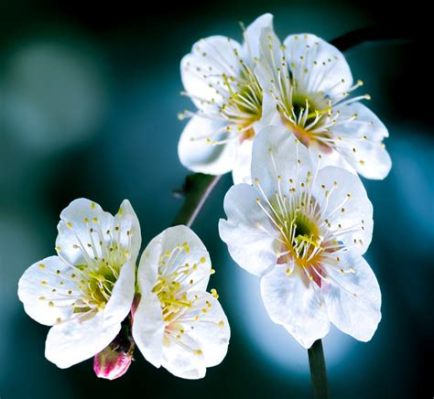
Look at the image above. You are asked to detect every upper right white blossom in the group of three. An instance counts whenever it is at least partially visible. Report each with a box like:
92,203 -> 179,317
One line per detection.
257,27 -> 391,179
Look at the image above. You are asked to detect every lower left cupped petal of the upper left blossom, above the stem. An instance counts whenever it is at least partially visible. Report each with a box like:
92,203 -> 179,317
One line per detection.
178,116 -> 238,175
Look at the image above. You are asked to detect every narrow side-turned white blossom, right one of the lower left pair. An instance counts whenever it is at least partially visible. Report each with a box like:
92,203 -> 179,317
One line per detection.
133,226 -> 230,379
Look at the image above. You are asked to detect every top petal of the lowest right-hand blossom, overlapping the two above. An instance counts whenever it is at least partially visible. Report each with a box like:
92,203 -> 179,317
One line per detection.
252,126 -> 314,197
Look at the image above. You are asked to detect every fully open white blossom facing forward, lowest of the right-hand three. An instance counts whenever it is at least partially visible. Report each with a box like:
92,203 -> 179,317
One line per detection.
219,127 -> 381,348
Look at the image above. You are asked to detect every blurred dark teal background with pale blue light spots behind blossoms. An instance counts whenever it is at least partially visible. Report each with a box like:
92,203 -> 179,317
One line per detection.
0,0 -> 434,399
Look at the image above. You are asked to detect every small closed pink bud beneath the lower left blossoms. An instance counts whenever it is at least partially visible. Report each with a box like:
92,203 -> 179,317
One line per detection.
93,341 -> 133,380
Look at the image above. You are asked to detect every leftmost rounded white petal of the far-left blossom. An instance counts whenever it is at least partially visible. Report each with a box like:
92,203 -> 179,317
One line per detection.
18,256 -> 81,326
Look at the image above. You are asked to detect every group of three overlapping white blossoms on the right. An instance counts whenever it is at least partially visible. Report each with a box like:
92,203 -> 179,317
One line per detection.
178,14 -> 391,348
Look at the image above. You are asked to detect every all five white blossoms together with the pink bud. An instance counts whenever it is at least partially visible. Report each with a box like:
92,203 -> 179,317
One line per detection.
18,14 -> 391,379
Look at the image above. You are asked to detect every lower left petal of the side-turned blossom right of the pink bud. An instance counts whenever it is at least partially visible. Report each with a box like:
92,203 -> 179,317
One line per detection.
133,293 -> 164,367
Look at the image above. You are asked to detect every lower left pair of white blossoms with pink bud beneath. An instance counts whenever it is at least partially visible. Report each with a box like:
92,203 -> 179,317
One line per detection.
18,199 -> 230,379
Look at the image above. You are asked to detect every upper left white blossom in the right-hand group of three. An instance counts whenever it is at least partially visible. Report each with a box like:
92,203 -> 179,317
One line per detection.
178,14 -> 272,182
